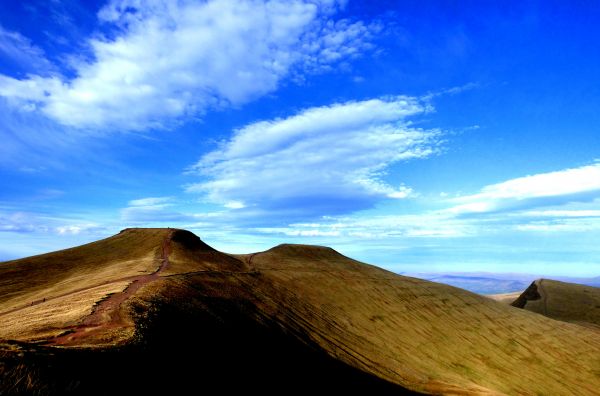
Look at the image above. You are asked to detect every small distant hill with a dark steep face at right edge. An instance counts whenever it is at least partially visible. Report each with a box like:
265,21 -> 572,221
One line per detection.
512,279 -> 600,329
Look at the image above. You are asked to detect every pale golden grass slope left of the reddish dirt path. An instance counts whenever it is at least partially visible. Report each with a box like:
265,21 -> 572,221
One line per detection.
0,229 -> 169,341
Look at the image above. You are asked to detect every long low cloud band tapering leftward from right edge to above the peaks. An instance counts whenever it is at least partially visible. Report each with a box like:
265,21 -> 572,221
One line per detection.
238,164 -> 600,243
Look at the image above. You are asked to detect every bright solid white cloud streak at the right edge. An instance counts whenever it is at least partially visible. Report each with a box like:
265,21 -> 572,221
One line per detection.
450,163 -> 600,214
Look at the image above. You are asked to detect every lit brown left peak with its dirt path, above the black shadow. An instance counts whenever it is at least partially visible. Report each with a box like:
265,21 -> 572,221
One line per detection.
0,229 -> 253,346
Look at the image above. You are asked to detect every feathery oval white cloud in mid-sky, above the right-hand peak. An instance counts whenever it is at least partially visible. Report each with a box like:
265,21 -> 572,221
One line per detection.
187,96 -> 440,216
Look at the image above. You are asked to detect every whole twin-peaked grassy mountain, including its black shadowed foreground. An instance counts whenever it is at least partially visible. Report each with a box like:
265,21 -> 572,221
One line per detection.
0,229 -> 600,395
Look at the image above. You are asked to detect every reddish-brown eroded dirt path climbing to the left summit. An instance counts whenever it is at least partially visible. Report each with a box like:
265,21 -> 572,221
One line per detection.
48,231 -> 173,345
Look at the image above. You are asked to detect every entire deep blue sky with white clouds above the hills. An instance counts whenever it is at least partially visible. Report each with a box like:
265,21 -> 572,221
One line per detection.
0,0 -> 600,277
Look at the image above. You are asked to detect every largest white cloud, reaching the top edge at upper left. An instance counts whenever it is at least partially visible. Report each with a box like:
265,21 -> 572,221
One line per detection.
0,0 -> 379,130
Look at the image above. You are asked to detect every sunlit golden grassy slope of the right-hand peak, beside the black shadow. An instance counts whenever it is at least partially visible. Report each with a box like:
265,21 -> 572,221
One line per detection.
236,245 -> 600,395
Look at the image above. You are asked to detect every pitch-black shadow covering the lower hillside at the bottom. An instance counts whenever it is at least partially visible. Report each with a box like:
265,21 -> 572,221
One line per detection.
0,276 -> 422,395
